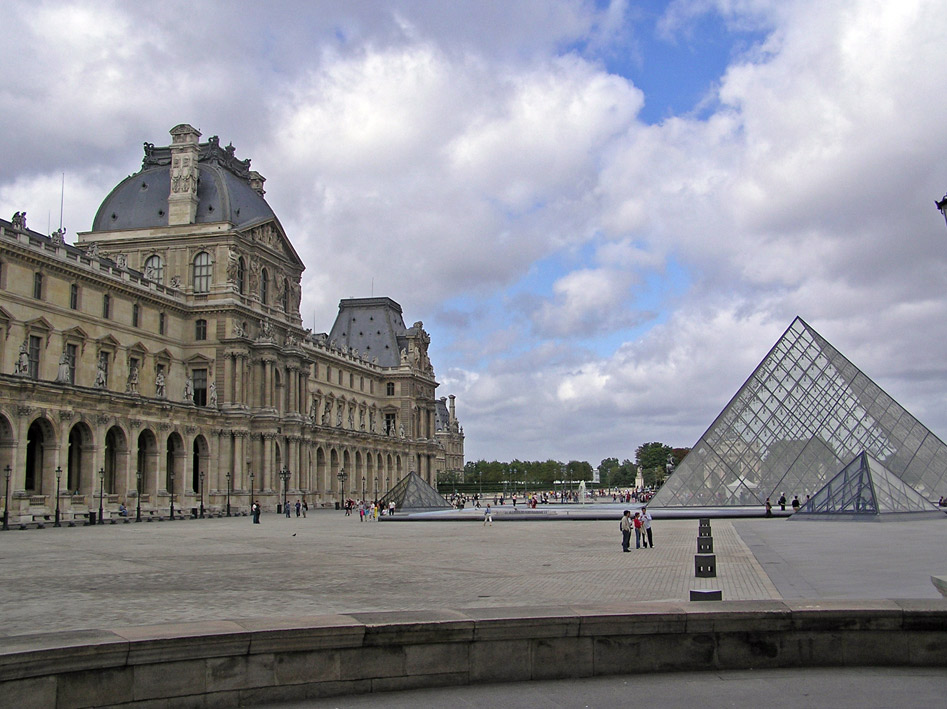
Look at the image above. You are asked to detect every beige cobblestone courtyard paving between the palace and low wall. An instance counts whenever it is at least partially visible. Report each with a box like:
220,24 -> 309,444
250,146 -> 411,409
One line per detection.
0,511 -> 780,635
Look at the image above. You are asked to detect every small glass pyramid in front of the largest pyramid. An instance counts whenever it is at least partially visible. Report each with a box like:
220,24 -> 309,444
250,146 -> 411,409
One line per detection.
792,451 -> 944,519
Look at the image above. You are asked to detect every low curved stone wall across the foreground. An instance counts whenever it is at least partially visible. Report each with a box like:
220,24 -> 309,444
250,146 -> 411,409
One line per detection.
0,599 -> 947,709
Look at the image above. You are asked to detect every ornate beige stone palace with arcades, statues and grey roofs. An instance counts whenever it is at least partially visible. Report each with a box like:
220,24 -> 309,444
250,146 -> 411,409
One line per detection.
0,125 -> 464,523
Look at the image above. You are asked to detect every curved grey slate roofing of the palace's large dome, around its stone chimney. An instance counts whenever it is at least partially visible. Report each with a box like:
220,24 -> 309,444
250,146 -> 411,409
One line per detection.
92,163 -> 275,232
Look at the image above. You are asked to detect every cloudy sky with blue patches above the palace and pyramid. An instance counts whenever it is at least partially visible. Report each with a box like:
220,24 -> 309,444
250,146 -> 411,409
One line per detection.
0,0 -> 947,464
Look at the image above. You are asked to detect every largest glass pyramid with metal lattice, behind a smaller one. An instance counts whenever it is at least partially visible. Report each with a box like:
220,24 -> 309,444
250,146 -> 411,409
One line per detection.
652,318 -> 947,507
